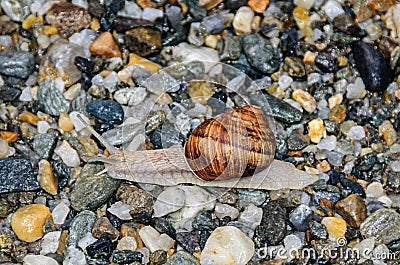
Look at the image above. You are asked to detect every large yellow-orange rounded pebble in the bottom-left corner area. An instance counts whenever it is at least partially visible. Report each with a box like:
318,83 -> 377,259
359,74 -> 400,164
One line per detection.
11,204 -> 50,242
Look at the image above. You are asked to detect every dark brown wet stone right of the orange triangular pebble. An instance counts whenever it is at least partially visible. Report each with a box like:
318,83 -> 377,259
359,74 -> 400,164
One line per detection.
124,27 -> 161,56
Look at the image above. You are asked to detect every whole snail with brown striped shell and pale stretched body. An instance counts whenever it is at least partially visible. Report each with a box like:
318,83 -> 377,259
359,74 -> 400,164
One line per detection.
77,106 -> 318,190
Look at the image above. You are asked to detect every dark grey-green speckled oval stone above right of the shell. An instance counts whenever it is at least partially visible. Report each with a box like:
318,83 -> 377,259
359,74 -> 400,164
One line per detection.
241,34 -> 279,74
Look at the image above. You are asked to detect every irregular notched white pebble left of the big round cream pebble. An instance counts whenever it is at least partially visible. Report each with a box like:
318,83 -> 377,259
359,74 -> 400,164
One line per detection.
139,226 -> 175,252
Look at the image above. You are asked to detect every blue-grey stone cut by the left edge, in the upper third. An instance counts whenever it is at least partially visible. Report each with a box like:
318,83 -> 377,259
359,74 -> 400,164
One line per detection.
0,50 -> 35,79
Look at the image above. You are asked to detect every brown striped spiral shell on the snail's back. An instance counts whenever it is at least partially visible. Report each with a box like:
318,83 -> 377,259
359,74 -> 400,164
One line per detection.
185,106 -> 276,180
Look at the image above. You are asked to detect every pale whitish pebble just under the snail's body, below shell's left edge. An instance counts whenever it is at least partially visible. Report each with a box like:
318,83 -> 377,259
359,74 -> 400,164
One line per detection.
153,187 -> 185,217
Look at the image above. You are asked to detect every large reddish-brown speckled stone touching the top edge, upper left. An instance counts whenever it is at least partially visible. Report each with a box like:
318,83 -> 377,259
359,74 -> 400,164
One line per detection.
46,2 -> 91,38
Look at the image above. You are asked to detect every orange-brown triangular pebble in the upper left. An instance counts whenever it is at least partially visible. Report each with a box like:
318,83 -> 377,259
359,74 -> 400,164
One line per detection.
89,32 -> 122,58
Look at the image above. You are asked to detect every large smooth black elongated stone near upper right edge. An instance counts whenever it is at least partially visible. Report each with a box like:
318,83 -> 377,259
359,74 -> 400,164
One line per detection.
353,41 -> 394,92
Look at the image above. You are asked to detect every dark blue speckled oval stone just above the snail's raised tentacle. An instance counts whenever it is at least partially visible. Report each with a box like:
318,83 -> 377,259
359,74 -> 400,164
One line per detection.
86,100 -> 124,124
